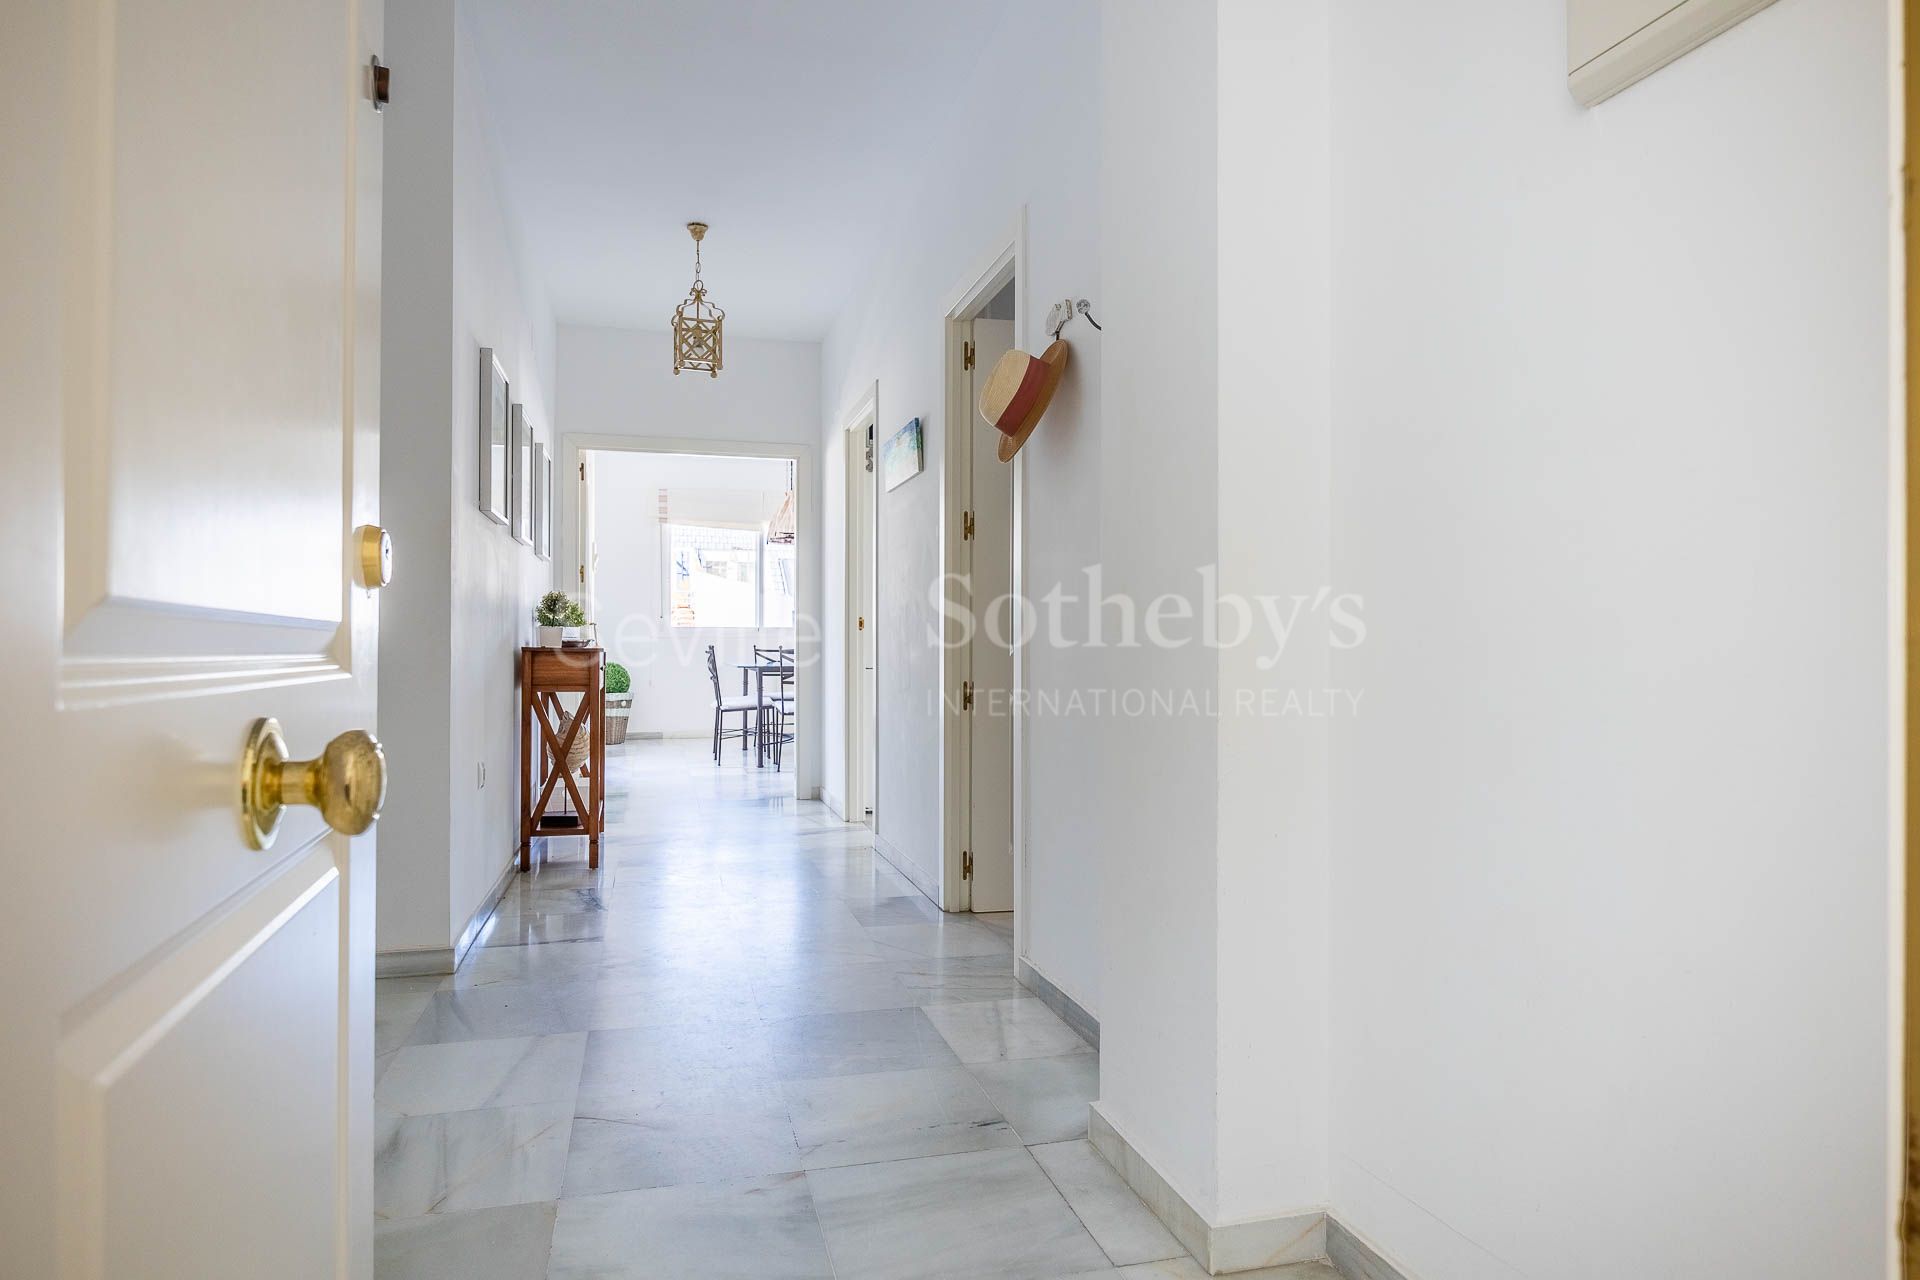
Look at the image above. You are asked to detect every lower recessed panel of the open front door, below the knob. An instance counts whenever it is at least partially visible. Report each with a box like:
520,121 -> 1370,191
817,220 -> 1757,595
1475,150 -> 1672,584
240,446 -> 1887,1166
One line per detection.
60,846 -> 342,1278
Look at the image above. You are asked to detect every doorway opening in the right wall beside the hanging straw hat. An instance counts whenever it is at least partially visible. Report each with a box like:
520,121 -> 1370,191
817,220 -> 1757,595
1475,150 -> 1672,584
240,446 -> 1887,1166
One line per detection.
941,228 -> 1025,921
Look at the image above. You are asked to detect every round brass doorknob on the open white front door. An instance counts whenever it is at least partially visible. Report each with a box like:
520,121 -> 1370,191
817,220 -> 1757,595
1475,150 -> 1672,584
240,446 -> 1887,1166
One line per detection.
240,718 -> 386,848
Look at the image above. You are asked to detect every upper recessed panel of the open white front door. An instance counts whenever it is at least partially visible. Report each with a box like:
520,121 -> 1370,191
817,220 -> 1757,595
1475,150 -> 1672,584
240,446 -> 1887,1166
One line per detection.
67,0 -> 351,647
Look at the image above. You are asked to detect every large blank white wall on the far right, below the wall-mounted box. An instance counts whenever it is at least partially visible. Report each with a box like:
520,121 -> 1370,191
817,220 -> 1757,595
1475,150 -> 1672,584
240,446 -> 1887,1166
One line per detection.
1332,0 -> 1897,1280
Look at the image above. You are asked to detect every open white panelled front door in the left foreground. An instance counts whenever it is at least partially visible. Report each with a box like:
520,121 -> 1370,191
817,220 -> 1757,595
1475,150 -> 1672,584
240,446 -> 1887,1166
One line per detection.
0,0 -> 385,1280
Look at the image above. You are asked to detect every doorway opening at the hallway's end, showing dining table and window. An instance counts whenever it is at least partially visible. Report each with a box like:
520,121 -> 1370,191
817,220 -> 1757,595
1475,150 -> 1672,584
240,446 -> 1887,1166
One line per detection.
563,438 -> 814,798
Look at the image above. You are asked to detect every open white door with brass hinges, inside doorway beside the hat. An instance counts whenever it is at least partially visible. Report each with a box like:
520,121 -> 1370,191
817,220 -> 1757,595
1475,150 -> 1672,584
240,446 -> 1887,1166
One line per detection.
966,320 -> 1014,912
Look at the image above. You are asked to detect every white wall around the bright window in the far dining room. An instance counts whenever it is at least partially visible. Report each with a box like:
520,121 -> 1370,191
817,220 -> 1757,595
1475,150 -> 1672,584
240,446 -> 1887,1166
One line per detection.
593,449 -> 793,737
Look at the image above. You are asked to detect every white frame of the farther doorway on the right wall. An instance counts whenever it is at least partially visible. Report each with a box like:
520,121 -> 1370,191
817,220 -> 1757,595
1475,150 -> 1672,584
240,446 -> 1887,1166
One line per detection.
841,382 -> 879,829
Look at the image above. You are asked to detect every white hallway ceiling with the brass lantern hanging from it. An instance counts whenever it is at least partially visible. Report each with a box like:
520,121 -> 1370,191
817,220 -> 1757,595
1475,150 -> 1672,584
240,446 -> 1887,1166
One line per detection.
467,0 -> 1012,340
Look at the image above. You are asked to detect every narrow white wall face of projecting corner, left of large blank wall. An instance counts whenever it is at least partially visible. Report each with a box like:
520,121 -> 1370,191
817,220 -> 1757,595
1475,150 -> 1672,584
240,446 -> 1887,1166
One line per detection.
1213,0 -> 1344,1222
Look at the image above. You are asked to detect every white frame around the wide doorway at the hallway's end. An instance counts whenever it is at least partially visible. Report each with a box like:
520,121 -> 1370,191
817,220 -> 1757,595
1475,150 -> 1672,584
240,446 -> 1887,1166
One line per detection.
553,432 -> 822,800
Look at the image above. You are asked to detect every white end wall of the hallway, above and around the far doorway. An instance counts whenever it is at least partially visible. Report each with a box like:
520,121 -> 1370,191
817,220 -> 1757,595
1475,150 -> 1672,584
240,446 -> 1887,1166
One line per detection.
553,324 -> 822,796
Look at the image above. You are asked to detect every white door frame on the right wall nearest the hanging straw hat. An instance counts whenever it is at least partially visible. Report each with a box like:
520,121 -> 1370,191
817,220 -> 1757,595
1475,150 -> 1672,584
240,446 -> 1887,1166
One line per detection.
941,214 -> 1031,924
